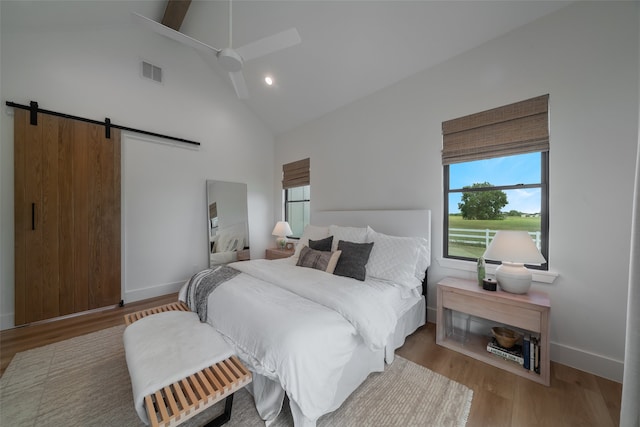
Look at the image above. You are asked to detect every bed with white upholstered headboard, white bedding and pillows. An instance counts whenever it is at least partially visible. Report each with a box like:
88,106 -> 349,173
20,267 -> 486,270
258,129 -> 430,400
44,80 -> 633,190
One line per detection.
179,210 -> 431,427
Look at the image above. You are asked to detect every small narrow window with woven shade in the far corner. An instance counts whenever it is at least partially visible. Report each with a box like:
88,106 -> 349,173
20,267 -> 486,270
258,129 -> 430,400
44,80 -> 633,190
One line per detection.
282,158 -> 311,238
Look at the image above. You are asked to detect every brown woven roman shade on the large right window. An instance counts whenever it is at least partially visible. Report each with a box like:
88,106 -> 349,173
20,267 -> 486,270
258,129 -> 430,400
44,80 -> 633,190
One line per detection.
442,95 -> 549,165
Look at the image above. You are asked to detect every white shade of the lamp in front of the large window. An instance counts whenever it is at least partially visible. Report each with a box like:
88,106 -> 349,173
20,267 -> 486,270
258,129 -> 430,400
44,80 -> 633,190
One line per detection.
483,230 -> 547,265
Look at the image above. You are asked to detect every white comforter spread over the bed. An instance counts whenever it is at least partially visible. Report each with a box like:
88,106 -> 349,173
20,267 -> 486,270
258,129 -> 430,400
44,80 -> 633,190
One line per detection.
180,260 -> 399,420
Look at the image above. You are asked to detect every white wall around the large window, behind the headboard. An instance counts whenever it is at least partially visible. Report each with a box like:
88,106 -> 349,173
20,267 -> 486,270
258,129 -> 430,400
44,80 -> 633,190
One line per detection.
274,2 -> 638,381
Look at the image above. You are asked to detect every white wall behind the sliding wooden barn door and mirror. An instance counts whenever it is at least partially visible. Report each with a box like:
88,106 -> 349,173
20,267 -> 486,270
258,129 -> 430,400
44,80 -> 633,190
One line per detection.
0,11 -> 274,329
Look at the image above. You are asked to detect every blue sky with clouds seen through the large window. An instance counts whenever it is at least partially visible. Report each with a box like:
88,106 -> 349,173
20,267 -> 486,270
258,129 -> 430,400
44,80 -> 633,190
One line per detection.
449,153 -> 541,213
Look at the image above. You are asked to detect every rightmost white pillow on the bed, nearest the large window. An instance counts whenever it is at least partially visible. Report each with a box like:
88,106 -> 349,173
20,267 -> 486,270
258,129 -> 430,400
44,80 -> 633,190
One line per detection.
367,227 -> 426,288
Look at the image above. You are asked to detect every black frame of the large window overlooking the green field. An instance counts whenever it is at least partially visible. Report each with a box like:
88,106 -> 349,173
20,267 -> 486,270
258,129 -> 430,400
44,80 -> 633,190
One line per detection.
442,151 -> 549,271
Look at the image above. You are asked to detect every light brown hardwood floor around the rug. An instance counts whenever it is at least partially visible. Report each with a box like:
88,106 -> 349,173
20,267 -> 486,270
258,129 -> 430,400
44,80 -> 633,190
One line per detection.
0,294 -> 622,427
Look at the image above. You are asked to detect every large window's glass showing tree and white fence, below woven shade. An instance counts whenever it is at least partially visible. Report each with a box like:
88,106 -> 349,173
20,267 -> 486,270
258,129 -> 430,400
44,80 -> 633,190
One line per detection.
444,152 -> 549,269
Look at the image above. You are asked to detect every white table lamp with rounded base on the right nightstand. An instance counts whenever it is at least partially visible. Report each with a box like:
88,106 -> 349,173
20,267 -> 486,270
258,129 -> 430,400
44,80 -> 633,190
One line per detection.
483,230 -> 547,294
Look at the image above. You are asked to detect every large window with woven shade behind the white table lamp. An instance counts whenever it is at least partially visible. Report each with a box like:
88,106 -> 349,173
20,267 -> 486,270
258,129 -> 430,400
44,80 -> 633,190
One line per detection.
442,95 -> 549,270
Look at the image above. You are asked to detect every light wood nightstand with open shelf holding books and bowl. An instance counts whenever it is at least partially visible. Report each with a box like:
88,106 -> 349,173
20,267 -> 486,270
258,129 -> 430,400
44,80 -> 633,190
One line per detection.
436,277 -> 551,386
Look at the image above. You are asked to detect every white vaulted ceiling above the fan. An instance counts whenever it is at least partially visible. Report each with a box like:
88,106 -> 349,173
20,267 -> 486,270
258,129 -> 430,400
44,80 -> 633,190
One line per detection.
2,0 -> 571,134
